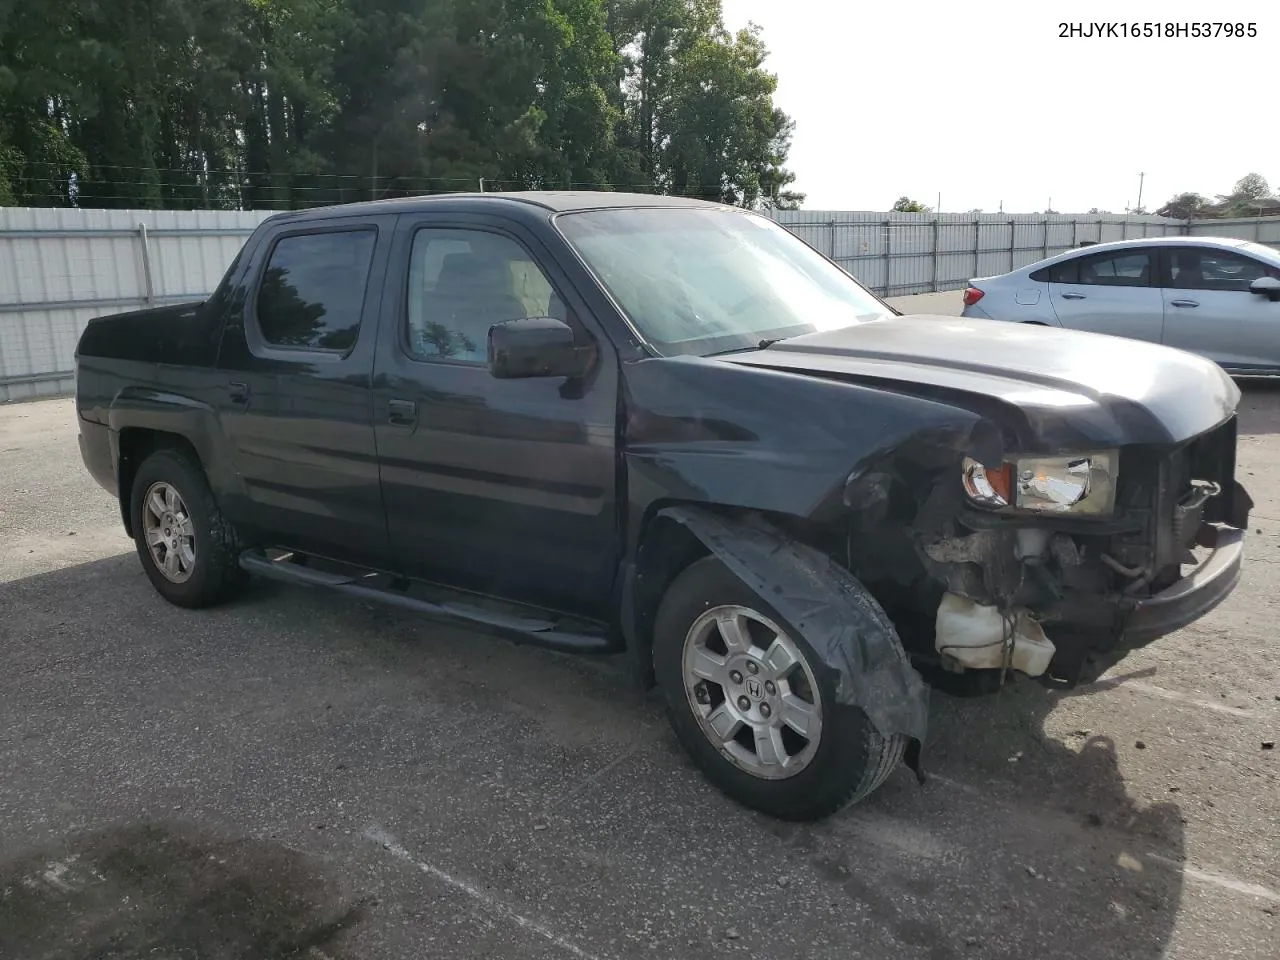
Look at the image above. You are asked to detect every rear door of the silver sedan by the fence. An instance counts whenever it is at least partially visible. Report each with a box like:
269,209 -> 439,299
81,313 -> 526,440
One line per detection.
1048,247 -> 1165,343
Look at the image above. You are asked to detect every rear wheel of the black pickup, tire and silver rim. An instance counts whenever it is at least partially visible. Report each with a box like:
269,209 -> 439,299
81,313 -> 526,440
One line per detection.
129,448 -> 244,608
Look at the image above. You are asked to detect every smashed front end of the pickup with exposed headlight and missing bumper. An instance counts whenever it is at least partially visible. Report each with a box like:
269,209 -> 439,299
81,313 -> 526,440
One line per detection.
850,416 -> 1253,691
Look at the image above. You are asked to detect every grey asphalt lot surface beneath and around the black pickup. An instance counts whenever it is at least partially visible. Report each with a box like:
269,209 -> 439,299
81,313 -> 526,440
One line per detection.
0,388 -> 1280,960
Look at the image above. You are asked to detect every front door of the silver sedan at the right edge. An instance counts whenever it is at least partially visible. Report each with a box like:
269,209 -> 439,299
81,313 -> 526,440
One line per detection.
1161,244 -> 1280,372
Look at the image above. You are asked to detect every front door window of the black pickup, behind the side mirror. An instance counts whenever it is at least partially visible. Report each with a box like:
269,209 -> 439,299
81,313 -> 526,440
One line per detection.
408,229 -> 570,364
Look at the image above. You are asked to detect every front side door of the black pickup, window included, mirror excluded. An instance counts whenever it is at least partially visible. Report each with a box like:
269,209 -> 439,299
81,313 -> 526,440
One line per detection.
374,215 -> 620,616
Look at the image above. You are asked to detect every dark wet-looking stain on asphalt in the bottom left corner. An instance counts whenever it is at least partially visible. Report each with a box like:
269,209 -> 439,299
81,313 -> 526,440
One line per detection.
0,824 -> 366,960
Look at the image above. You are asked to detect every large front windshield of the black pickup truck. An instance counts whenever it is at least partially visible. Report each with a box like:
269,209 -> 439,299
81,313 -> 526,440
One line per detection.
556,207 -> 892,356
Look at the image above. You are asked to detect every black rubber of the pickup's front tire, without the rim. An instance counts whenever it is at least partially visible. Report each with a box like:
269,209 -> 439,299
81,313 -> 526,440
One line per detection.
653,557 -> 879,820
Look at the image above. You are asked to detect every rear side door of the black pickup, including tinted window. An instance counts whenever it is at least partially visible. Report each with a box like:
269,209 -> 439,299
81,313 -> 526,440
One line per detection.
216,216 -> 394,566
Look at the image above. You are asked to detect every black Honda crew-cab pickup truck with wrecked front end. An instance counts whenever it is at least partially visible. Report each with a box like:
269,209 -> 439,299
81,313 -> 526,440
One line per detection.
76,193 -> 1252,819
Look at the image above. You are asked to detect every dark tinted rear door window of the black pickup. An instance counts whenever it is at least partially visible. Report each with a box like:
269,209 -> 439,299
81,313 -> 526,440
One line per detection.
257,230 -> 376,352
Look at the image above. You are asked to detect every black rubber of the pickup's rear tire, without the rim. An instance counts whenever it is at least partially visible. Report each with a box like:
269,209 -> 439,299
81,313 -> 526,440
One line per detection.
129,449 -> 238,607
